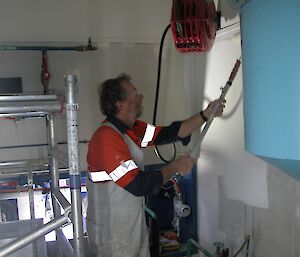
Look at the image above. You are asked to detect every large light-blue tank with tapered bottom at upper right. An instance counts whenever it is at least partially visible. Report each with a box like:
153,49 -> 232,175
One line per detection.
241,0 -> 300,180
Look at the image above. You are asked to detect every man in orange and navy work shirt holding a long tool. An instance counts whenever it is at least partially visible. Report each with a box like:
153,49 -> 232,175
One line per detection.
87,74 -> 224,257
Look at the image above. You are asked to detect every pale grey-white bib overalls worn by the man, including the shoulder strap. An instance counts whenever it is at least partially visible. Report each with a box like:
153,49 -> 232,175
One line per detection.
87,122 -> 150,257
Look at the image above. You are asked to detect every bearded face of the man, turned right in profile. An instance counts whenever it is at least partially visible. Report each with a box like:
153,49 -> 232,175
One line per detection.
122,81 -> 143,119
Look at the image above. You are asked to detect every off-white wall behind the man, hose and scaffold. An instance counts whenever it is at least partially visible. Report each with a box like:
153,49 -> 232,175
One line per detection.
0,0 -> 300,257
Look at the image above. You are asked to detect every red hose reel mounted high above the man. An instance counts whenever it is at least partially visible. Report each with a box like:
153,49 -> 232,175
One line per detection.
171,0 -> 218,53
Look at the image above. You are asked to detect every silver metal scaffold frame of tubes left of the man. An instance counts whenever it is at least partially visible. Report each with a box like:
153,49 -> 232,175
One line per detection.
0,75 -> 84,257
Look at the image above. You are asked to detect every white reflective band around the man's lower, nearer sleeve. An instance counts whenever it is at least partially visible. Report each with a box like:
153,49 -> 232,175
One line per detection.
89,160 -> 137,182
